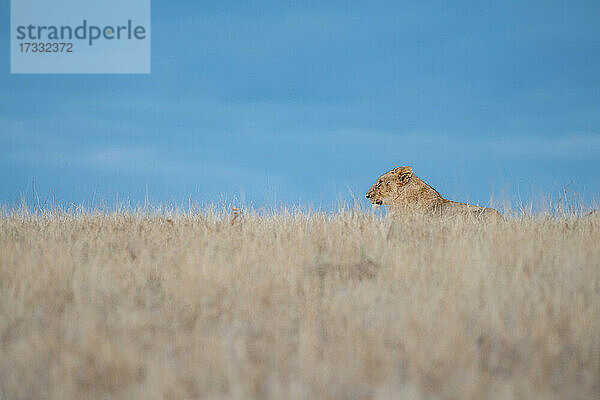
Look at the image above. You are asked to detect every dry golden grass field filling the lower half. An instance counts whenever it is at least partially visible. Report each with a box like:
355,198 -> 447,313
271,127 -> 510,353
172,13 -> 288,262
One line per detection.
0,205 -> 600,400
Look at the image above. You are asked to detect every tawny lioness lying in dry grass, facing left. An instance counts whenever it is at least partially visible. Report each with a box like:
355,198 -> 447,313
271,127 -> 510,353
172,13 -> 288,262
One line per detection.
367,167 -> 503,219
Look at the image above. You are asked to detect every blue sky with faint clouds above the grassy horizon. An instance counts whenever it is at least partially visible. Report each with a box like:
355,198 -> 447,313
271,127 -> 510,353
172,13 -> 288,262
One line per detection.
0,0 -> 600,208
